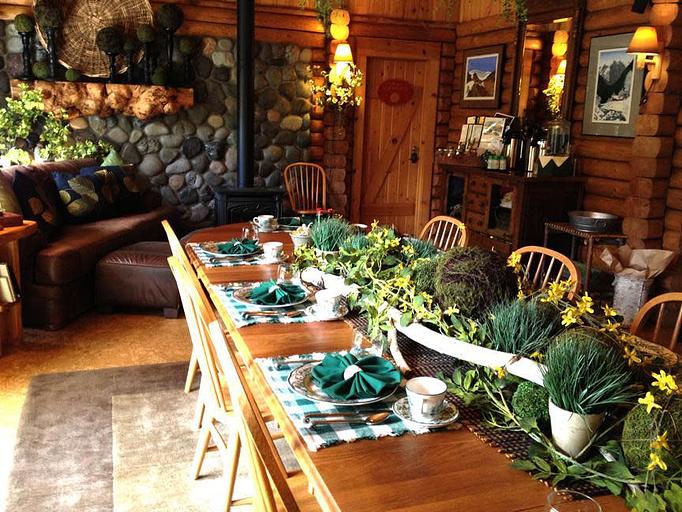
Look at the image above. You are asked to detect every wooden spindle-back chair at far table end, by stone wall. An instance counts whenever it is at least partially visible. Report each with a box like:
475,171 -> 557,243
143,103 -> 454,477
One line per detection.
284,162 -> 327,214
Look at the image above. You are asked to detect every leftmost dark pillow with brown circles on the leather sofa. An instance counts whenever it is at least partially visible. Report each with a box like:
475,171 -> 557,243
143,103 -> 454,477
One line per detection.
12,168 -> 61,240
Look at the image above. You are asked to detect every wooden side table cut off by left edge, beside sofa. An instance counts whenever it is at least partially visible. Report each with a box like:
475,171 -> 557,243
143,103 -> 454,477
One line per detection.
0,220 -> 38,355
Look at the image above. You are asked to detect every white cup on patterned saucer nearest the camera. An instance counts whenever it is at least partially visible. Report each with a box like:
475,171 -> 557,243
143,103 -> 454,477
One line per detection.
393,377 -> 459,428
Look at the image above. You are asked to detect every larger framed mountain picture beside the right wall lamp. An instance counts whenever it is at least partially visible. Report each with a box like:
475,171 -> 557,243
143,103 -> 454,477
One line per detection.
583,34 -> 644,137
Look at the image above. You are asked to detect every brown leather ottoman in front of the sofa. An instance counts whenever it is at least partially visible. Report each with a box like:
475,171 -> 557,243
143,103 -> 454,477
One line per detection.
95,242 -> 180,318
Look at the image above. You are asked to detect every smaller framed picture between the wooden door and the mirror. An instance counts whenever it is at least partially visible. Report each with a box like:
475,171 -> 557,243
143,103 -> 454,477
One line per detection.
462,45 -> 504,108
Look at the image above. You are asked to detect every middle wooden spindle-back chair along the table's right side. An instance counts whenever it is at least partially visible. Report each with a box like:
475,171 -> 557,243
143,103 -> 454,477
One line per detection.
514,245 -> 580,298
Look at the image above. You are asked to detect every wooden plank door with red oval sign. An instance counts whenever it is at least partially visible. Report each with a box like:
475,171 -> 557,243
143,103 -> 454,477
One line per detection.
351,38 -> 440,233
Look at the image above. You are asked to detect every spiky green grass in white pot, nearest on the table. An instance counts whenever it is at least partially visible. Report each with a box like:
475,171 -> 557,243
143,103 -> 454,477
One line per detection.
542,328 -> 633,458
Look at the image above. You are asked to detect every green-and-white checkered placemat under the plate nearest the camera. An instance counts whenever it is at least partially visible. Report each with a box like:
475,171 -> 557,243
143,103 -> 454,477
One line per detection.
256,353 -> 428,452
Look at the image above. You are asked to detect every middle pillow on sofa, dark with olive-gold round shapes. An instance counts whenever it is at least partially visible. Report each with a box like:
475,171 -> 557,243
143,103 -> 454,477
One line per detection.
52,172 -> 100,223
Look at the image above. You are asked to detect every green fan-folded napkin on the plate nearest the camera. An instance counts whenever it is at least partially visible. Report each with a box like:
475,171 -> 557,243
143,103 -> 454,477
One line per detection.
312,354 -> 400,400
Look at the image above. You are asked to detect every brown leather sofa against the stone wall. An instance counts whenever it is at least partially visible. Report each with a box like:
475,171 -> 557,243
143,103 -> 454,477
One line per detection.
1,159 -> 175,330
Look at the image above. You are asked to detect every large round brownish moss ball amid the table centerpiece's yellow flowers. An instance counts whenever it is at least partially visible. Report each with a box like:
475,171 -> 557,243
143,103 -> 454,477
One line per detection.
435,247 -> 517,318
